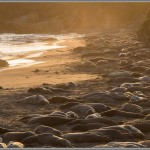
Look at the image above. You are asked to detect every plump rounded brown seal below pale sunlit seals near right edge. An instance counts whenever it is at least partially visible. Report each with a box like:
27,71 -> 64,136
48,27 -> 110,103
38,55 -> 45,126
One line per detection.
121,103 -> 143,113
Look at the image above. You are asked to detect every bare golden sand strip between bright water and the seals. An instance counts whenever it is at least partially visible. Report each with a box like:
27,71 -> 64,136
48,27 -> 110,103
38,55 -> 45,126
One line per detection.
0,38 -> 96,88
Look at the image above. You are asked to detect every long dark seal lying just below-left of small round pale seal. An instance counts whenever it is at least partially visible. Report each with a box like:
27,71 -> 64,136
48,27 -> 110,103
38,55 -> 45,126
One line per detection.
29,116 -> 74,126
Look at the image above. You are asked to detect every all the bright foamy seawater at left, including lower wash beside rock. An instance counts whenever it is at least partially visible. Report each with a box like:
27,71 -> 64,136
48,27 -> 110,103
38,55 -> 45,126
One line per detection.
0,33 -> 84,67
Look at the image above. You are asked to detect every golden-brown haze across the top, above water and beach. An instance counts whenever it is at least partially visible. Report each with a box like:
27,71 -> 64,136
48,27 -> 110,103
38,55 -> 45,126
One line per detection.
0,2 -> 150,34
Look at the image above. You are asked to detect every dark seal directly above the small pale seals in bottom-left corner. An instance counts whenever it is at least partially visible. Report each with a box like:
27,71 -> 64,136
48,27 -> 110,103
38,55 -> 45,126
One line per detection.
3,131 -> 35,142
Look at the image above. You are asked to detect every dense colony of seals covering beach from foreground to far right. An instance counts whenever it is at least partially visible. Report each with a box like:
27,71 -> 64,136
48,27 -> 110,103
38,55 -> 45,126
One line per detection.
0,19 -> 150,148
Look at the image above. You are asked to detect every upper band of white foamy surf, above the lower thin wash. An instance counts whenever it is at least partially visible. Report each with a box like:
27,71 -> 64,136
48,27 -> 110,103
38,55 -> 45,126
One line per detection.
0,33 -> 83,57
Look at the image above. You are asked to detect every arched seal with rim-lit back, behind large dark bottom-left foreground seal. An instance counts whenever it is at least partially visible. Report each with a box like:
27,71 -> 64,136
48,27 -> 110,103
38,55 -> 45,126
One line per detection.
34,125 -> 63,137
